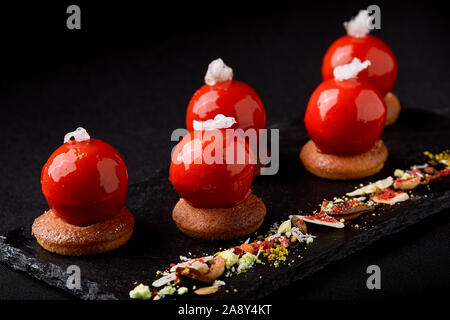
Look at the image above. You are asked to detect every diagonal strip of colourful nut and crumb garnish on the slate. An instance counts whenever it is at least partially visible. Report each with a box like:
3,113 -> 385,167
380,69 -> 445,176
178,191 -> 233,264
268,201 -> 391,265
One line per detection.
129,150 -> 450,300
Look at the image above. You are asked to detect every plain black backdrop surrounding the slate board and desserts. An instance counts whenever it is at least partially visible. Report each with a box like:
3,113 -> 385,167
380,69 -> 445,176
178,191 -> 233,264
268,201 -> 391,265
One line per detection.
0,1 -> 450,299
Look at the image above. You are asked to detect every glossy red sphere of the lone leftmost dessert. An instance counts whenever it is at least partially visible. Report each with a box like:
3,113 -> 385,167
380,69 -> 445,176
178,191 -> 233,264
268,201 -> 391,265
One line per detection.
41,139 -> 128,226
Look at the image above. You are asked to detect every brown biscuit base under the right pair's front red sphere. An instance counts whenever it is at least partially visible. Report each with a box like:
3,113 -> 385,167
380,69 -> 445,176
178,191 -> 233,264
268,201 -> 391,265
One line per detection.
300,140 -> 388,180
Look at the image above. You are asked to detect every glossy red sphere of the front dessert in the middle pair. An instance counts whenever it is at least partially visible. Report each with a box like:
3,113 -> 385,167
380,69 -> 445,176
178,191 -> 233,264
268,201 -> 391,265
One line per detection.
169,130 -> 255,208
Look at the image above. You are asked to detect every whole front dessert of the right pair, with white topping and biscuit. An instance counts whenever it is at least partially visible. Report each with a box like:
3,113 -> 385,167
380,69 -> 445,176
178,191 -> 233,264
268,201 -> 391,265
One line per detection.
300,58 -> 388,180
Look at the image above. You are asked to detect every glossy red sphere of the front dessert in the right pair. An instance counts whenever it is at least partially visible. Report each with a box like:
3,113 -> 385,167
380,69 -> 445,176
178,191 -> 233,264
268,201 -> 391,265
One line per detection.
305,78 -> 386,155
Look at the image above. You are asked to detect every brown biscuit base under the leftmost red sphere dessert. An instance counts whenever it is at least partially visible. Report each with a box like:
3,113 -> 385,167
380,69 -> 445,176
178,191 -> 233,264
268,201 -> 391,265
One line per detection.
32,208 -> 134,256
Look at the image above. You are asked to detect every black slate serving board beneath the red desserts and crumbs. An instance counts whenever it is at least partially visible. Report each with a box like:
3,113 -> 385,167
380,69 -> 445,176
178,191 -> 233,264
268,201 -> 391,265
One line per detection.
0,109 -> 450,299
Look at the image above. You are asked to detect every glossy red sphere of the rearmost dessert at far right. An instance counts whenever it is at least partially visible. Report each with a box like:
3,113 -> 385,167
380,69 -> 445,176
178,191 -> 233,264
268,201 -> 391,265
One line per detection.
322,35 -> 398,97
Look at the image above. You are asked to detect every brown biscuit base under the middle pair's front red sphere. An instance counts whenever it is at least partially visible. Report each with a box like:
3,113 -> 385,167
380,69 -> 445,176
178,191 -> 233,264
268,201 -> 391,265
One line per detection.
172,194 -> 266,240
